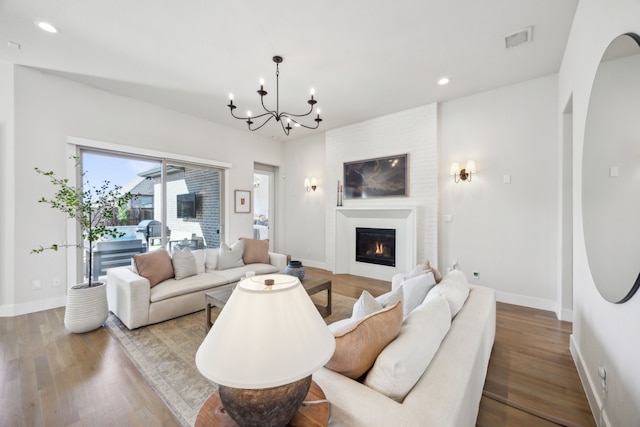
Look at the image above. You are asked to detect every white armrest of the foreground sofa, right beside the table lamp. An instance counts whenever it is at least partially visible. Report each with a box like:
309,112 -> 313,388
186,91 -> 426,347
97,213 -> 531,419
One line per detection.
313,367 -> 428,427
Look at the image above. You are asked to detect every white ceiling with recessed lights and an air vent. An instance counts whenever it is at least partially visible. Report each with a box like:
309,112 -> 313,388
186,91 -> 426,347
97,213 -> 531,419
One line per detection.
0,0 -> 578,139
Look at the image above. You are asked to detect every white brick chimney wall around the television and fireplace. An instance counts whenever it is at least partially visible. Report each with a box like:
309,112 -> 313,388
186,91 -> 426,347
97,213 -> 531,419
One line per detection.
325,104 -> 438,278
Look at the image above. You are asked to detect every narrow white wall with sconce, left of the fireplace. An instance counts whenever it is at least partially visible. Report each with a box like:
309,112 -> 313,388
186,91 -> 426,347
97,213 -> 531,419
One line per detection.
282,134 -> 333,268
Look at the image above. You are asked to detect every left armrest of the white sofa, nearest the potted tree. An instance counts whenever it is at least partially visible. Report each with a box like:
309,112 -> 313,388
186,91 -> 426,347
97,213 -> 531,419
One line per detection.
107,267 -> 151,329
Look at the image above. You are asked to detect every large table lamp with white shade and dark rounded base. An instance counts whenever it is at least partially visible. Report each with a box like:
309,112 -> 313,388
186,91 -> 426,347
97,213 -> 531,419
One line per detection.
196,274 -> 335,427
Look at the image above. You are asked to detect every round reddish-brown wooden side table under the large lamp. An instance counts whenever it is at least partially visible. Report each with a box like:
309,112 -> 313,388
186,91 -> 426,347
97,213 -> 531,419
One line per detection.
195,381 -> 329,427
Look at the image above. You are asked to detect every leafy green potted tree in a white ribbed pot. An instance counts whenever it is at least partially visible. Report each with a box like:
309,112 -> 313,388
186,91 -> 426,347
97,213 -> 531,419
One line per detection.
31,156 -> 134,333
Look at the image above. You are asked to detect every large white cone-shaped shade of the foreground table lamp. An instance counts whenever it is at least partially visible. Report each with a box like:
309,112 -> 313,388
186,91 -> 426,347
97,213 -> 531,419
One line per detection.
196,274 -> 335,389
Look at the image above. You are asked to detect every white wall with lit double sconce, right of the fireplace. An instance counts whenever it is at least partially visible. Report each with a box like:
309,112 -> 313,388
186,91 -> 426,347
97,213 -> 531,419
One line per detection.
439,76 -> 559,310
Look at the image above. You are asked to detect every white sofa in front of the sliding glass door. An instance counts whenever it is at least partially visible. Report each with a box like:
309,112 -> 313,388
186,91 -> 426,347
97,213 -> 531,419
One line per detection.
107,241 -> 287,329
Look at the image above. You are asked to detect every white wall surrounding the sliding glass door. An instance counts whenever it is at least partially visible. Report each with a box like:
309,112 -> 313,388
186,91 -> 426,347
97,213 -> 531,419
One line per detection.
0,67 -> 282,314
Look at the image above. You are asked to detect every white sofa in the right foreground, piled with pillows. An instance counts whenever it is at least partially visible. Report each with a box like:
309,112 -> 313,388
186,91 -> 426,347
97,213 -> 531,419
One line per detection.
313,270 -> 496,427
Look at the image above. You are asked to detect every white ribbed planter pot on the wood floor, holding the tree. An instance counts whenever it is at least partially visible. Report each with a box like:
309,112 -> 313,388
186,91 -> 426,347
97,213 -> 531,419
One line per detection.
64,283 -> 109,334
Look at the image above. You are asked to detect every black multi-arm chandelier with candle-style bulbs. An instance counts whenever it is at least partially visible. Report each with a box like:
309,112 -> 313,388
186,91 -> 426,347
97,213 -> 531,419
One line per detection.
227,56 -> 322,136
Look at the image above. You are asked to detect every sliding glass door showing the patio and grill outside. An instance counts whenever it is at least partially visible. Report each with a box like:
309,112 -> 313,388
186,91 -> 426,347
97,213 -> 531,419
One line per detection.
81,149 -> 223,280
